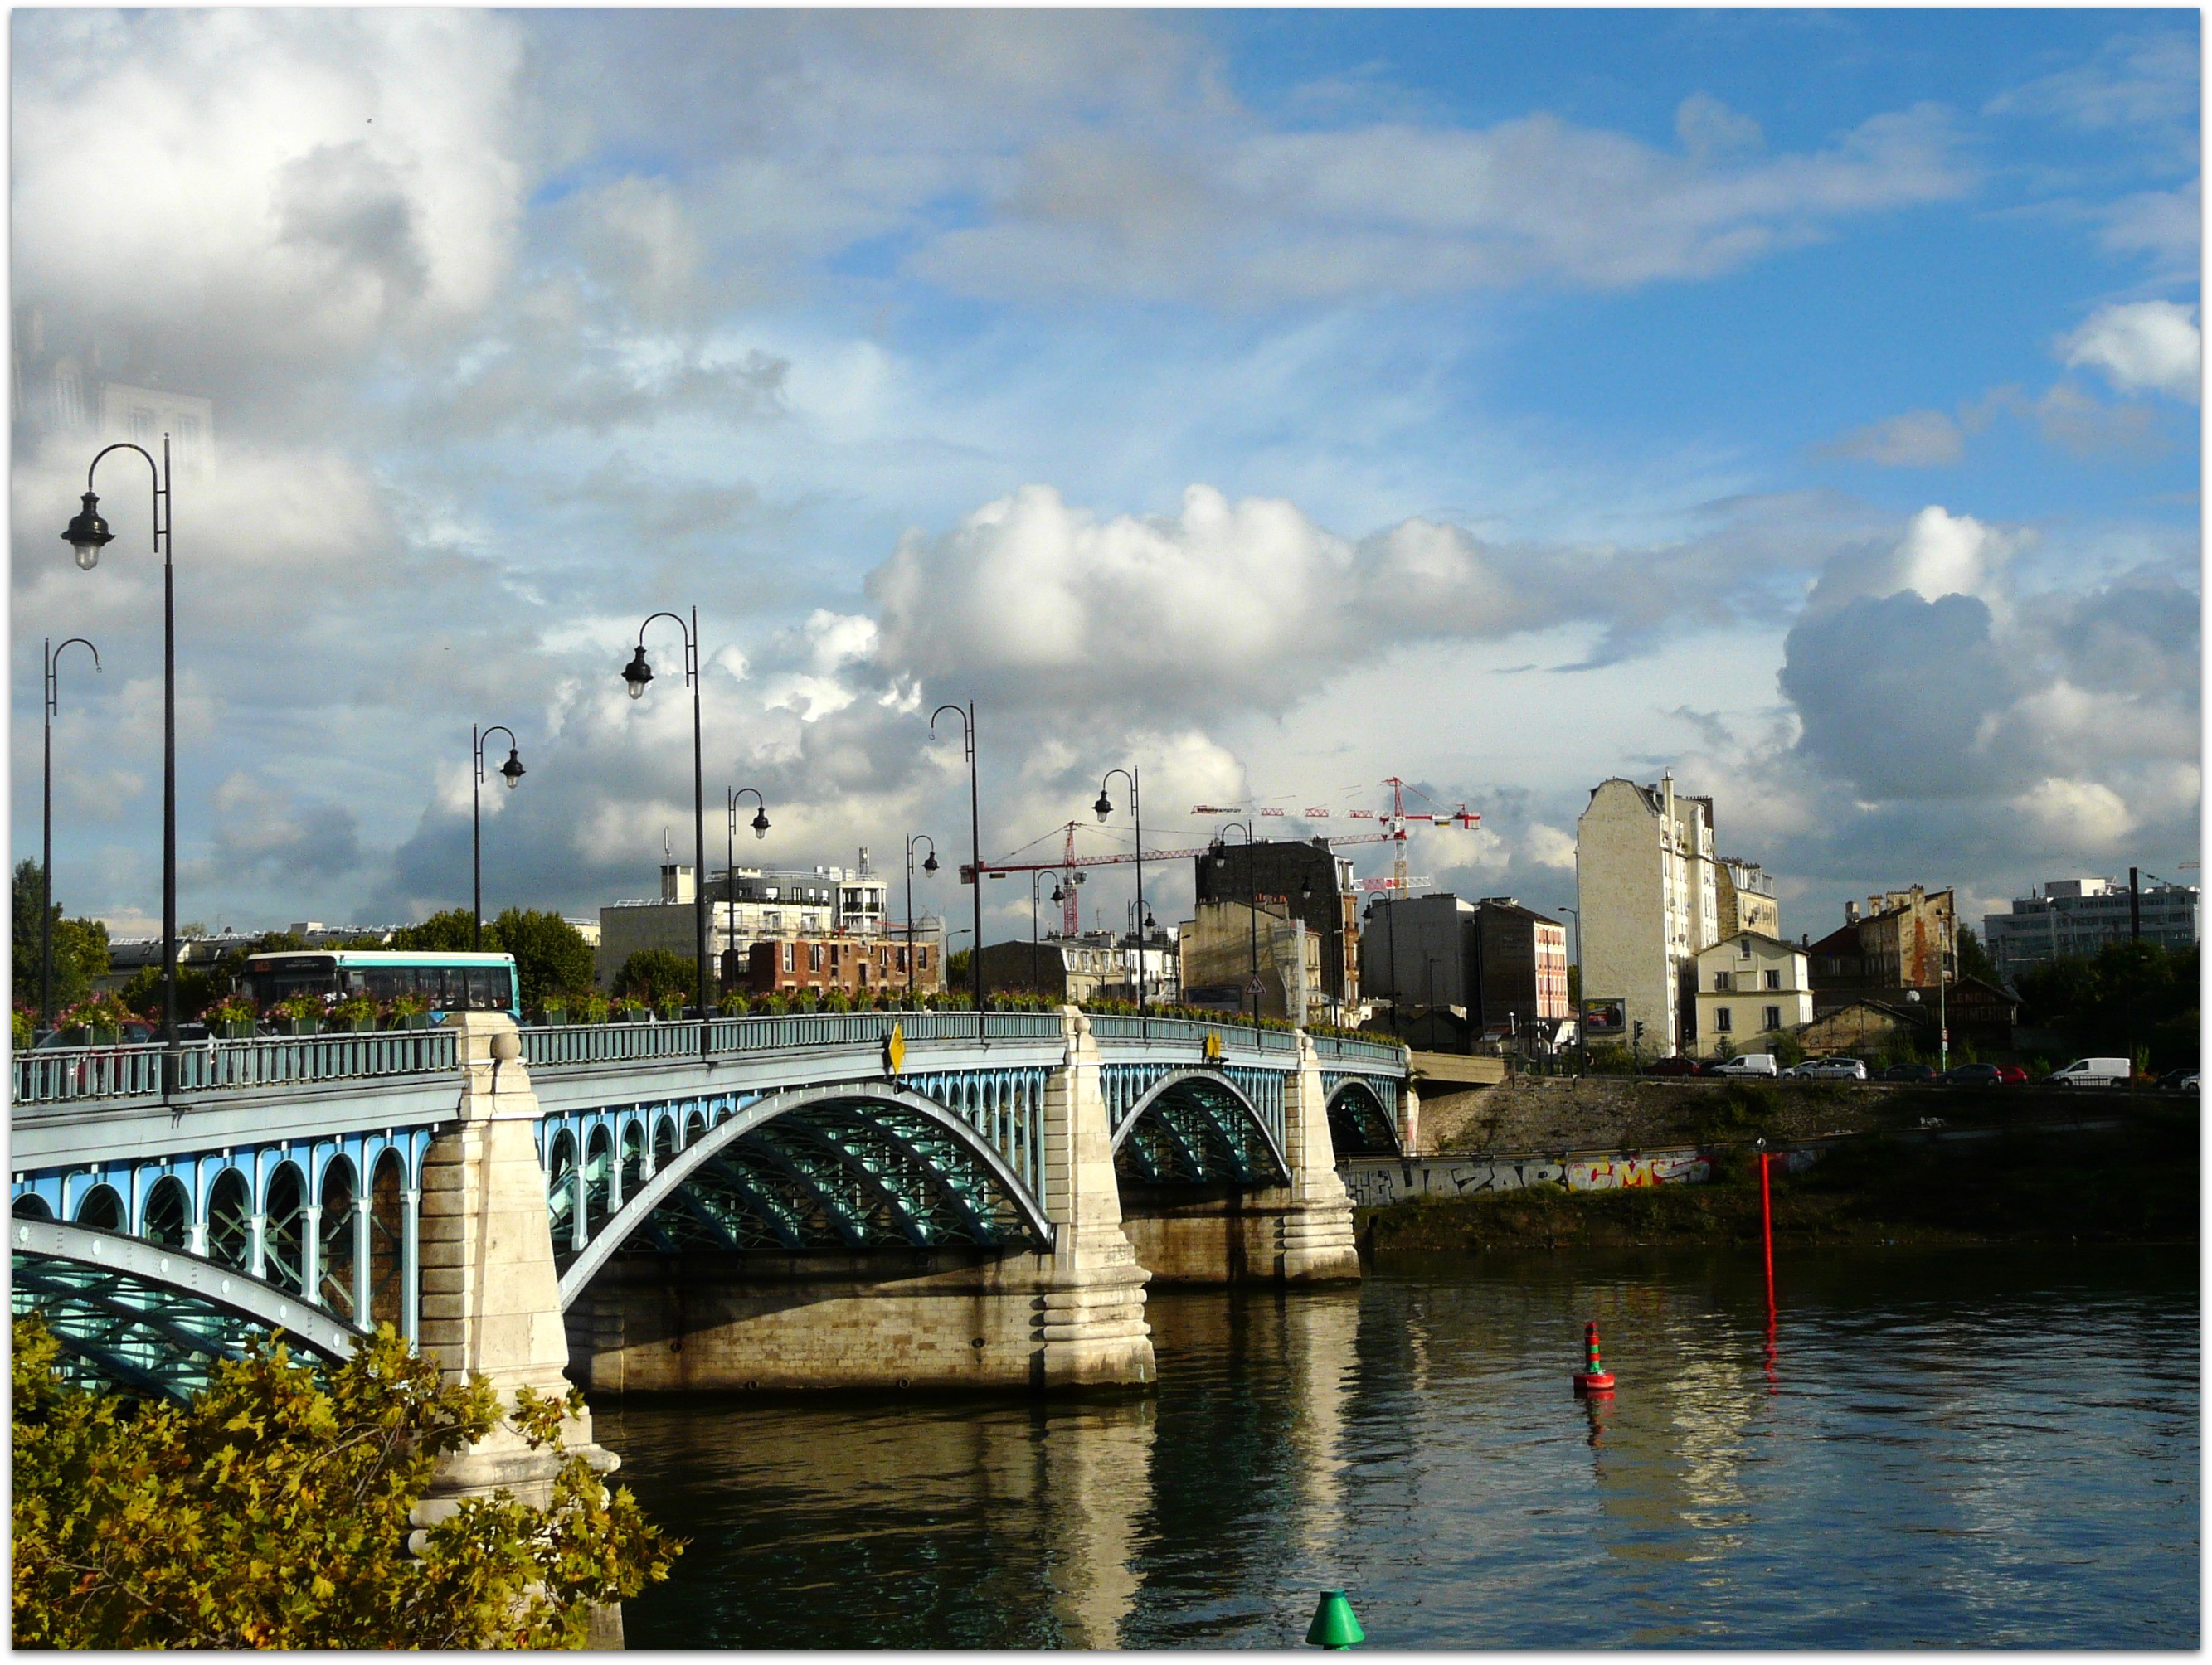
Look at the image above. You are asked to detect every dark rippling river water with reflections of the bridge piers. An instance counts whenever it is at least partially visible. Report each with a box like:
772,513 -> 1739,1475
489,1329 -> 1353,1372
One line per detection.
597,1250 -> 2201,1649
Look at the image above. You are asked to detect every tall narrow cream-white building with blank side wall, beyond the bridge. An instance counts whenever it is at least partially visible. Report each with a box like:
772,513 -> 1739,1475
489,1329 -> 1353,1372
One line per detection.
1575,774 -> 1721,1057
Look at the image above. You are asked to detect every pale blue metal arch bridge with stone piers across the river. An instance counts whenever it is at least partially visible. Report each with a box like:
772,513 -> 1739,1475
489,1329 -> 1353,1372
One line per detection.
11,1008 -> 1409,1389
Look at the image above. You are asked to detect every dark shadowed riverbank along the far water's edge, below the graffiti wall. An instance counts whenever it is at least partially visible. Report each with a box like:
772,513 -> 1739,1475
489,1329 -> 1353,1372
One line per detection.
1356,1104 -> 2201,1254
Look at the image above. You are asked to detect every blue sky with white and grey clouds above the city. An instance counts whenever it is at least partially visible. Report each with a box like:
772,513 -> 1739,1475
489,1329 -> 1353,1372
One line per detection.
11,11 -> 2201,935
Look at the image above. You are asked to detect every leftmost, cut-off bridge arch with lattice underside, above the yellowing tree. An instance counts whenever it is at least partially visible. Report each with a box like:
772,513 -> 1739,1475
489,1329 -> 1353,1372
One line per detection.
9,1221 -> 361,1397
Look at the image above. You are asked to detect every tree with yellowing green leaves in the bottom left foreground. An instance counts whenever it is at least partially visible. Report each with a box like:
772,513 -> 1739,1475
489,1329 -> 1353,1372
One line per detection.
11,1318 -> 683,1649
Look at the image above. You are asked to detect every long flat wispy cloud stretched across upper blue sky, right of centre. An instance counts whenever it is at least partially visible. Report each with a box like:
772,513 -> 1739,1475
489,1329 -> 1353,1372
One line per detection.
909,106 -> 1969,303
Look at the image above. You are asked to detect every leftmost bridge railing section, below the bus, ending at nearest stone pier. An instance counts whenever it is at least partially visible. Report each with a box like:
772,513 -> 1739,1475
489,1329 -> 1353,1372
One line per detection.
11,1028 -> 460,1108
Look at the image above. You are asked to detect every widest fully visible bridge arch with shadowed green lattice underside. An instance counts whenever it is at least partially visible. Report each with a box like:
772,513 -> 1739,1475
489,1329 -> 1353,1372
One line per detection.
553,1084 -> 1053,1309
